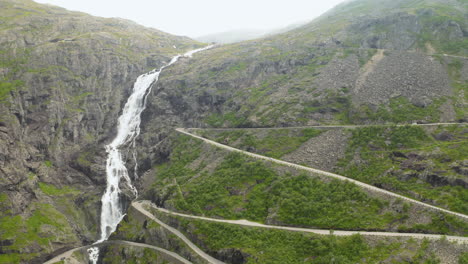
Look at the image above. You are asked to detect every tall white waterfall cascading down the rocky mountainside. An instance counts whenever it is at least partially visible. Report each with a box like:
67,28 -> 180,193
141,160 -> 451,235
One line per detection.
88,46 -> 212,264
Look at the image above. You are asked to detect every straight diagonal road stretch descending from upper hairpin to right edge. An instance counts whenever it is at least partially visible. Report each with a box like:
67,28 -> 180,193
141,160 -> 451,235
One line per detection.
176,126 -> 468,220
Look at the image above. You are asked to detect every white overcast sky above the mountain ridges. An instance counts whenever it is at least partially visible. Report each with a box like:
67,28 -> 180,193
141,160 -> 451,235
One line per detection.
35,0 -> 344,37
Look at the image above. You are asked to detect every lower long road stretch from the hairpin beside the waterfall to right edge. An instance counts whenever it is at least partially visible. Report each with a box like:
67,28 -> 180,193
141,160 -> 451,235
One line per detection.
132,201 -> 468,244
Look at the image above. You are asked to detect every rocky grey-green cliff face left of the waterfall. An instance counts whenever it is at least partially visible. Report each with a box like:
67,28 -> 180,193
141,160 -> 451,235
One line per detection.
0,0 -> 199,263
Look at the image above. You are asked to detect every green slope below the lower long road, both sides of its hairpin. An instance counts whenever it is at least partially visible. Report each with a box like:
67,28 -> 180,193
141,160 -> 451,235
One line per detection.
111,204 -> 467,264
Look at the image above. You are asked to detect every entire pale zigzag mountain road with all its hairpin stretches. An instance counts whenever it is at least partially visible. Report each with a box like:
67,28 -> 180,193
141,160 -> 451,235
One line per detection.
44,123 -> 468,264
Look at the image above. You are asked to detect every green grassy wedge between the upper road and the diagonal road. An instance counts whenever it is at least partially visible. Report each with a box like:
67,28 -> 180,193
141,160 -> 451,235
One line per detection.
195,125 -> 468,217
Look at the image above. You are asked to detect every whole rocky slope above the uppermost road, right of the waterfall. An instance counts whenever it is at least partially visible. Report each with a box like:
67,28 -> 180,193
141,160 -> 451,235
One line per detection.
141,0 -> 467,132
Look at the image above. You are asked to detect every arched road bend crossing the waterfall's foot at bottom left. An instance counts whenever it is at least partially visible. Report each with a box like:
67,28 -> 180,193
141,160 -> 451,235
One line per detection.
44,240 -> 192,264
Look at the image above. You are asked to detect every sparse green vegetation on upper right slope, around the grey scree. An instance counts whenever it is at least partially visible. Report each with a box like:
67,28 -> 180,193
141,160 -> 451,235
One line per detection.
176,0 -> 468,127
